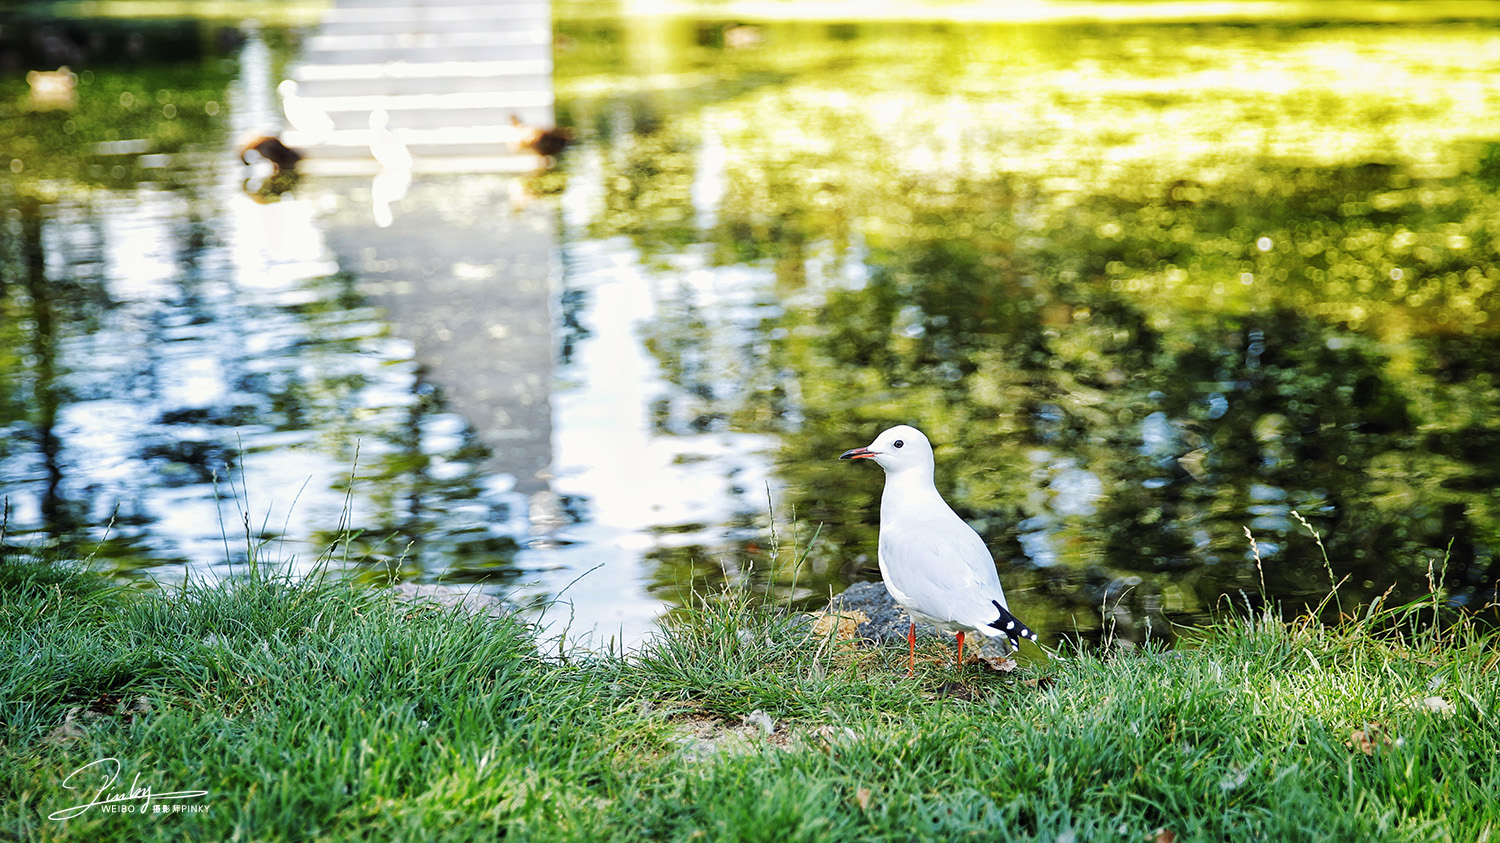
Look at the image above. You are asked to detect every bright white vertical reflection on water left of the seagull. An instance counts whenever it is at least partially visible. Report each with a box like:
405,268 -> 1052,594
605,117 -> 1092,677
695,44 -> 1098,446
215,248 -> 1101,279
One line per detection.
522,234 -> 773,644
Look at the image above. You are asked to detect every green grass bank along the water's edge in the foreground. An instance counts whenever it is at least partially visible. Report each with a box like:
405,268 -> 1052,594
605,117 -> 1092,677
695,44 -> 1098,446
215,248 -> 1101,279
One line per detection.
0,560 -> 1500,842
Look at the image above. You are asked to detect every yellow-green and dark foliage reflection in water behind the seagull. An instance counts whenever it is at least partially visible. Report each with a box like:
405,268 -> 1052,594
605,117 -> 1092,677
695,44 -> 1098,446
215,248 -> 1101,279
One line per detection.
561,14 -> 1500,636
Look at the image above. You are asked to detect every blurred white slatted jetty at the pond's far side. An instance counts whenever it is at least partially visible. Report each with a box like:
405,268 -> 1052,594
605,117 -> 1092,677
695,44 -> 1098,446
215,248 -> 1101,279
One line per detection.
281,0 -> 555,176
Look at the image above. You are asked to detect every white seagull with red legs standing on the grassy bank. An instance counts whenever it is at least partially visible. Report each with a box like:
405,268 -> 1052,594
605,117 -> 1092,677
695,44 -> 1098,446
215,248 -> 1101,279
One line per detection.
839,425 -> 1037,675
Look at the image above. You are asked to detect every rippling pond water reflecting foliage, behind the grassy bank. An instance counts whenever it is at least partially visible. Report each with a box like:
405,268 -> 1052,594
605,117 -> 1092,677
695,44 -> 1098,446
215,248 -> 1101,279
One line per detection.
0,6 -> 1500,645
